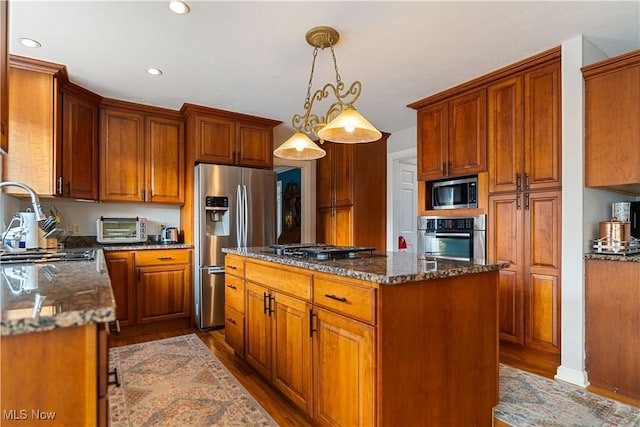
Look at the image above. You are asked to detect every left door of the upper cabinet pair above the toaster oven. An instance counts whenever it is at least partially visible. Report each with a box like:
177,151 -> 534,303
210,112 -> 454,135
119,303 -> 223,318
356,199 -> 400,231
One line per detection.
100,108 -> 145,202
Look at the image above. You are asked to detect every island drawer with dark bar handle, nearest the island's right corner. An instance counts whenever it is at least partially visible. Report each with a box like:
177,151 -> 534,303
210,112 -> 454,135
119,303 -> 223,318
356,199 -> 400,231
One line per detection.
313,276 -> 376,325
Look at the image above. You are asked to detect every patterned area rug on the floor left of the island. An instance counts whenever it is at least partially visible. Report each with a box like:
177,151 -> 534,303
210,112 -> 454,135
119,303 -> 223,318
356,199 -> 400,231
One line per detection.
109,334 -> 277,427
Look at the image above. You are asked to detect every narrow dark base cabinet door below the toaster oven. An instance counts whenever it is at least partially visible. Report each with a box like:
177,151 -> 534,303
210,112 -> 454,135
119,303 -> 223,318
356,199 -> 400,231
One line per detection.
105,251 -> 136,326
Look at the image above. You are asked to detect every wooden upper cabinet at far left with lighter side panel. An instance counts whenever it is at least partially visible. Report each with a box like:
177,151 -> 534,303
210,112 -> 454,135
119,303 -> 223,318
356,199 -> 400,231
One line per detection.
3,56 -> 100,200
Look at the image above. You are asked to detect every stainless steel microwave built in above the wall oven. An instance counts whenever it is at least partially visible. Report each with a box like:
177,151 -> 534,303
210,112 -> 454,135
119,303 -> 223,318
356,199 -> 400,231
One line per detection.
431,176 -> 478,209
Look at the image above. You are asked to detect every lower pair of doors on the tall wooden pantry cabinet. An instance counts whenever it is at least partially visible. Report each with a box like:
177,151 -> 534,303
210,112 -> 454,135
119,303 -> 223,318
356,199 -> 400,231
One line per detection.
487,191 -> 562,354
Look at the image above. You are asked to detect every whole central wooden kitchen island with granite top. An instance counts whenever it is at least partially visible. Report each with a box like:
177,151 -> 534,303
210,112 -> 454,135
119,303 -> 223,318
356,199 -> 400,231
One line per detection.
223,248 -> 506,426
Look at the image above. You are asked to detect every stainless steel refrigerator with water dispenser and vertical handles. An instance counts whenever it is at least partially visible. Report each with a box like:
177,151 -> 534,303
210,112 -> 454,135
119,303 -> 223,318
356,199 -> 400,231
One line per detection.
194,164 -> 276,330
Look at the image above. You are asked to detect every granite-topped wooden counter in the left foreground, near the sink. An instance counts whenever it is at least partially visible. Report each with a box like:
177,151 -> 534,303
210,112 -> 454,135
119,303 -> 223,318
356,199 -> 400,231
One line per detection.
0,250 -> 115,426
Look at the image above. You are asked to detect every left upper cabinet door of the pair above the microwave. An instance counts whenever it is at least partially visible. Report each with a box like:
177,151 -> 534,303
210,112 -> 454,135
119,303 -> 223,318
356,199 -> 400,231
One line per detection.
418,102 -> 449,180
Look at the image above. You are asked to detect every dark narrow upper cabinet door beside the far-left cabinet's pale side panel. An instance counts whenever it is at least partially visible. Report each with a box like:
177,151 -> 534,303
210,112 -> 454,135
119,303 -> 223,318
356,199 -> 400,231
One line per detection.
59,89 -> 98,200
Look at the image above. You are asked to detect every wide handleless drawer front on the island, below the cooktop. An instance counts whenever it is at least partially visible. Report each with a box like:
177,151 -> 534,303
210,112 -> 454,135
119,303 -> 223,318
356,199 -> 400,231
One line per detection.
244,261 -> 311,301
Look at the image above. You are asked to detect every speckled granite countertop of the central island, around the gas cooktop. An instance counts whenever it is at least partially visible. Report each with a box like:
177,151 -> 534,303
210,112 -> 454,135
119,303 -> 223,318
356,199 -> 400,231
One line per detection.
222,247 -> 509,285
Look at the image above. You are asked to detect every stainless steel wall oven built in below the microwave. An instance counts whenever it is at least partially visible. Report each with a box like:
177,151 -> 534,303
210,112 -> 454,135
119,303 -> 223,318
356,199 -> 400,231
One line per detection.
418,215 -> 486,264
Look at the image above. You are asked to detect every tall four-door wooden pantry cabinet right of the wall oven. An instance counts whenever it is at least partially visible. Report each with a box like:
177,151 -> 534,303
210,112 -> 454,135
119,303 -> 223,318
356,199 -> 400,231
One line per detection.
487,49 -> 562,354
